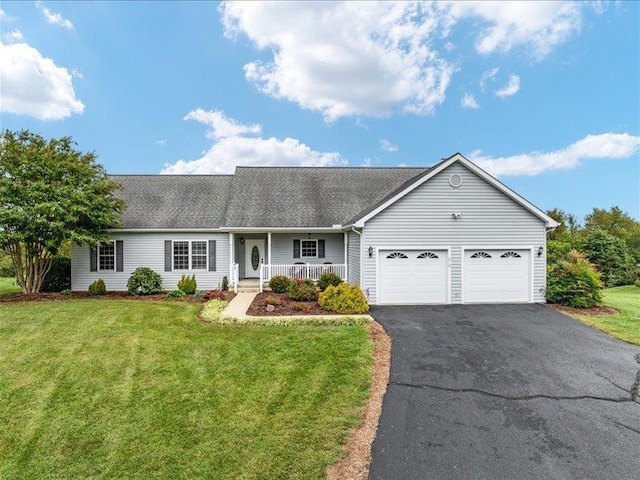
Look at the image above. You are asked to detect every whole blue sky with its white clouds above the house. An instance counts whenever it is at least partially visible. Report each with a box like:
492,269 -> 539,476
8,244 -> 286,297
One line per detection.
0,1 -> 640,219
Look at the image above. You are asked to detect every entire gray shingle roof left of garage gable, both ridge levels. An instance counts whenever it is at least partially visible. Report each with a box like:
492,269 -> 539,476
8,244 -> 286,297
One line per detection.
111,167 -> 428,229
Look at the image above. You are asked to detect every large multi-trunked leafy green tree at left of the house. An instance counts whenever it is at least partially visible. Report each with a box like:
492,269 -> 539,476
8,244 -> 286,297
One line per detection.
0,130 -> 124,293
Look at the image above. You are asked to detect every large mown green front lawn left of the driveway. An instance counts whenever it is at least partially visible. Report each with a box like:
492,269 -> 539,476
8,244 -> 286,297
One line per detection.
0,299 -> 373,479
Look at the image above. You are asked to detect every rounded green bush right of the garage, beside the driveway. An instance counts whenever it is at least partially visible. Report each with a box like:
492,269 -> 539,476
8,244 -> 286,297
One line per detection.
547,250 -> 602,308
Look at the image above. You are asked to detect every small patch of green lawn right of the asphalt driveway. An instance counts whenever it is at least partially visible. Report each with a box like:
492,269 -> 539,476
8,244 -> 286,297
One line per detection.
575,285 -> 640,345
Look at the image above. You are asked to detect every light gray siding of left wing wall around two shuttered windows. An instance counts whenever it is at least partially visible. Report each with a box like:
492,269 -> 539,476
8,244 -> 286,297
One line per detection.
71,233 -> 229,291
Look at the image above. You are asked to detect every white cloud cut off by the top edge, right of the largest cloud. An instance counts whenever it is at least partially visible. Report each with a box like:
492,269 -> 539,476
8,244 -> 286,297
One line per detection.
448,1 -> 586,60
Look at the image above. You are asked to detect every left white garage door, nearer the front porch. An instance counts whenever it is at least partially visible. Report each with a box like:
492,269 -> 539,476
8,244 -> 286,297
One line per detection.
378,250 -> 448,304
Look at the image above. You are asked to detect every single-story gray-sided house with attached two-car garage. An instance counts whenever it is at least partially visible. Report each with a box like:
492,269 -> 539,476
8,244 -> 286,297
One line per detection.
72,154 -> 557,304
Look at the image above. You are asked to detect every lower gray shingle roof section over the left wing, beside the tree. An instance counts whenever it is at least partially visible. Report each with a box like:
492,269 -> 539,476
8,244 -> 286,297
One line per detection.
111,175 -> 233,229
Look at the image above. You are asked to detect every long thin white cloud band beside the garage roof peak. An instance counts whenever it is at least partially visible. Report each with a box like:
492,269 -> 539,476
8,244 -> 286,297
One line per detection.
469,133 -> 640,176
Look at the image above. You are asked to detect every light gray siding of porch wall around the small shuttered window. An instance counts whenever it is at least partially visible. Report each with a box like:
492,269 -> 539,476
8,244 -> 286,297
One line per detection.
271,232 -> 344,265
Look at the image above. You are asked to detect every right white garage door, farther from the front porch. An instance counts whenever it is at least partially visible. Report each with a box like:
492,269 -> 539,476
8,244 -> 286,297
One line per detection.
462,249 -> 531,303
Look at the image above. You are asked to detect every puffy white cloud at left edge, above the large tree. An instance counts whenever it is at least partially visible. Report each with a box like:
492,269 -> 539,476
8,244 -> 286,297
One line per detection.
0,42 -> 84,120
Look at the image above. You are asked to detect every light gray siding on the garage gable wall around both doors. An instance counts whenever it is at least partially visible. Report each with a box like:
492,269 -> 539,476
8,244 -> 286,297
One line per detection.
361,163 -> 546,304
